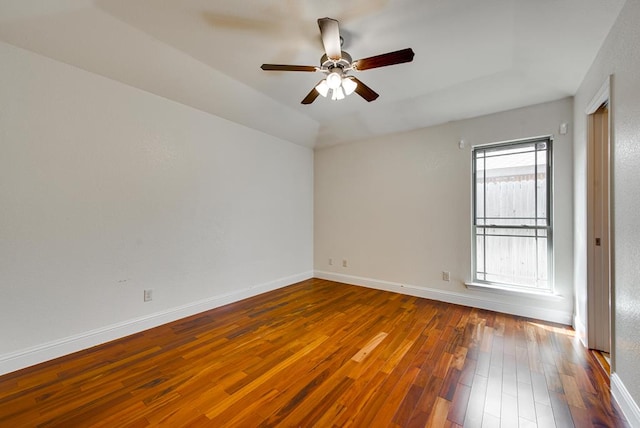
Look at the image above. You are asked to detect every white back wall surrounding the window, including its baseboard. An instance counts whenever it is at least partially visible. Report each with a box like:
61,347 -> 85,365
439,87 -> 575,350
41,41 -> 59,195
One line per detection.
314,98 -> 573,324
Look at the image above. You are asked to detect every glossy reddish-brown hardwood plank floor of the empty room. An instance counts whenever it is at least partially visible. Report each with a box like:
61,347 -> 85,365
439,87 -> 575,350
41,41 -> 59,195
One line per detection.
0,279 -> 626,428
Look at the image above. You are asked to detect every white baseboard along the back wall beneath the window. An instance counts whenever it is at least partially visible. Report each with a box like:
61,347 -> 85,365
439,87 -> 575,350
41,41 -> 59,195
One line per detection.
314,271 -> 573,325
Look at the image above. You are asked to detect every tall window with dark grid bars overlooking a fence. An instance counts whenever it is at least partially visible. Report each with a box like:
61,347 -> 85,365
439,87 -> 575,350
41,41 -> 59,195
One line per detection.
473,137 -> 553,292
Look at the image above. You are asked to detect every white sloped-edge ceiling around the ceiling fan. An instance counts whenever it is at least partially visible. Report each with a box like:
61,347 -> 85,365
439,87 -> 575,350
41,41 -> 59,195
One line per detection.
0,0 -> 624,147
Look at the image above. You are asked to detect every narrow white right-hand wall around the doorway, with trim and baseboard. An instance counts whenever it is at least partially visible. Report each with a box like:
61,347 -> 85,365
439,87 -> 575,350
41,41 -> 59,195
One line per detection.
574,1 -> 640,426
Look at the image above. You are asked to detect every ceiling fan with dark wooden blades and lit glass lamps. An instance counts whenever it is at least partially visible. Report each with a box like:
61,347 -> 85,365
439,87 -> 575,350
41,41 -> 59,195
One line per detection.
260,18 -> 414,104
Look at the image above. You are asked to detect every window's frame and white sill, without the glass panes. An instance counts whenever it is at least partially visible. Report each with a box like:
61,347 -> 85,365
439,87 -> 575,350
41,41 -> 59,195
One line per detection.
467,136 -> 554,295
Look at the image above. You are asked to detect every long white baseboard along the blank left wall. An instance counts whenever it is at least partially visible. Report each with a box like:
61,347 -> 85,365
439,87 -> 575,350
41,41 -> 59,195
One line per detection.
0,272 -> 313,375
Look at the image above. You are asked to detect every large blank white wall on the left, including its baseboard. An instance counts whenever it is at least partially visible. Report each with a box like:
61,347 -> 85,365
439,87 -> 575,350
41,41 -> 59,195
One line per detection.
0,43 -> 313,373
